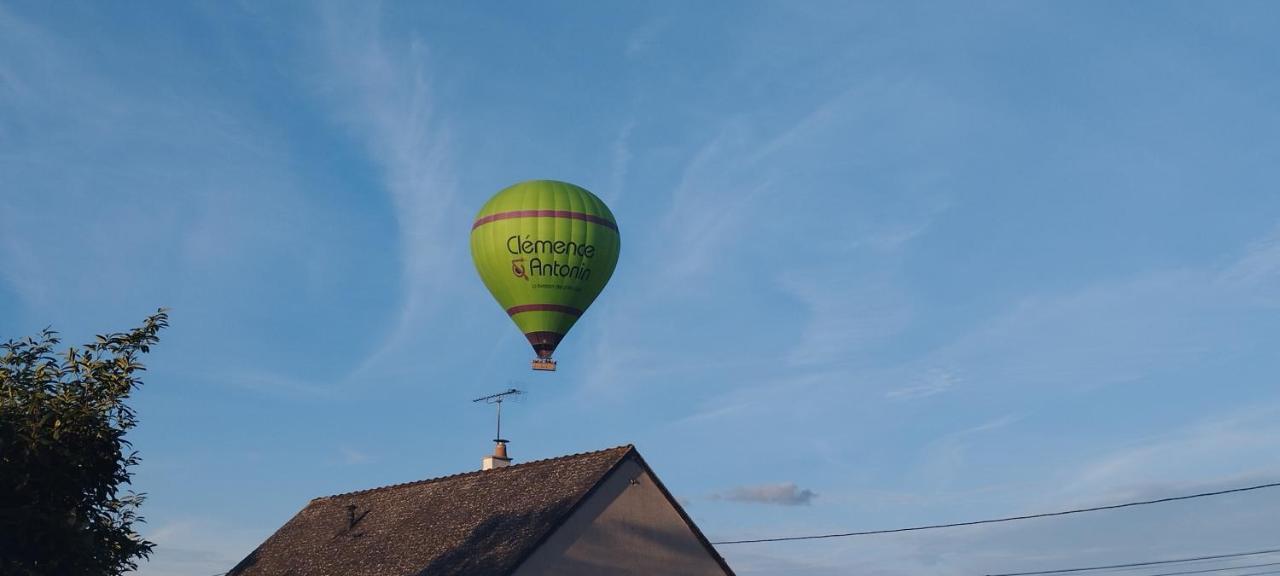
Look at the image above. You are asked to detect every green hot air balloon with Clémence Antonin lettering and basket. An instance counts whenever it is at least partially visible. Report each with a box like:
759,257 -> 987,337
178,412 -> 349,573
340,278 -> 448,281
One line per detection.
471,180 -> 621,370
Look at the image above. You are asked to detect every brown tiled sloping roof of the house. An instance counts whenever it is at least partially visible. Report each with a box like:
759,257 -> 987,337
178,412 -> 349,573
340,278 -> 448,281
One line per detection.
228,444 -> 640,576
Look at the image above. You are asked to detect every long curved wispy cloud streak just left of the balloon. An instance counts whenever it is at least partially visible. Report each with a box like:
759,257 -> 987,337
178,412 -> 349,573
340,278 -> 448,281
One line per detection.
314,5 -> 465,381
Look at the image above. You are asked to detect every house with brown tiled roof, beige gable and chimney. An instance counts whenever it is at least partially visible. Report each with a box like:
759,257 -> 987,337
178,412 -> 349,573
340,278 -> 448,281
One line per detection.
228,443 -> 733,576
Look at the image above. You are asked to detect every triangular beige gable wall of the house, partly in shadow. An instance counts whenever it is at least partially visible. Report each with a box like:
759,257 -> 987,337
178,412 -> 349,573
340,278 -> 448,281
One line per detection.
515,460 -> 726,576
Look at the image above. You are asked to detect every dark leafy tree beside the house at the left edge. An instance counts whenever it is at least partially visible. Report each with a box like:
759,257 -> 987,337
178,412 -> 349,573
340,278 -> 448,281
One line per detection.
0,308 -> 169,576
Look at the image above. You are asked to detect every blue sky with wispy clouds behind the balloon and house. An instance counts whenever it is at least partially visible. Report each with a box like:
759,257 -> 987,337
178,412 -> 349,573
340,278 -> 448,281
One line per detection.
0,1 -> 1280,576
